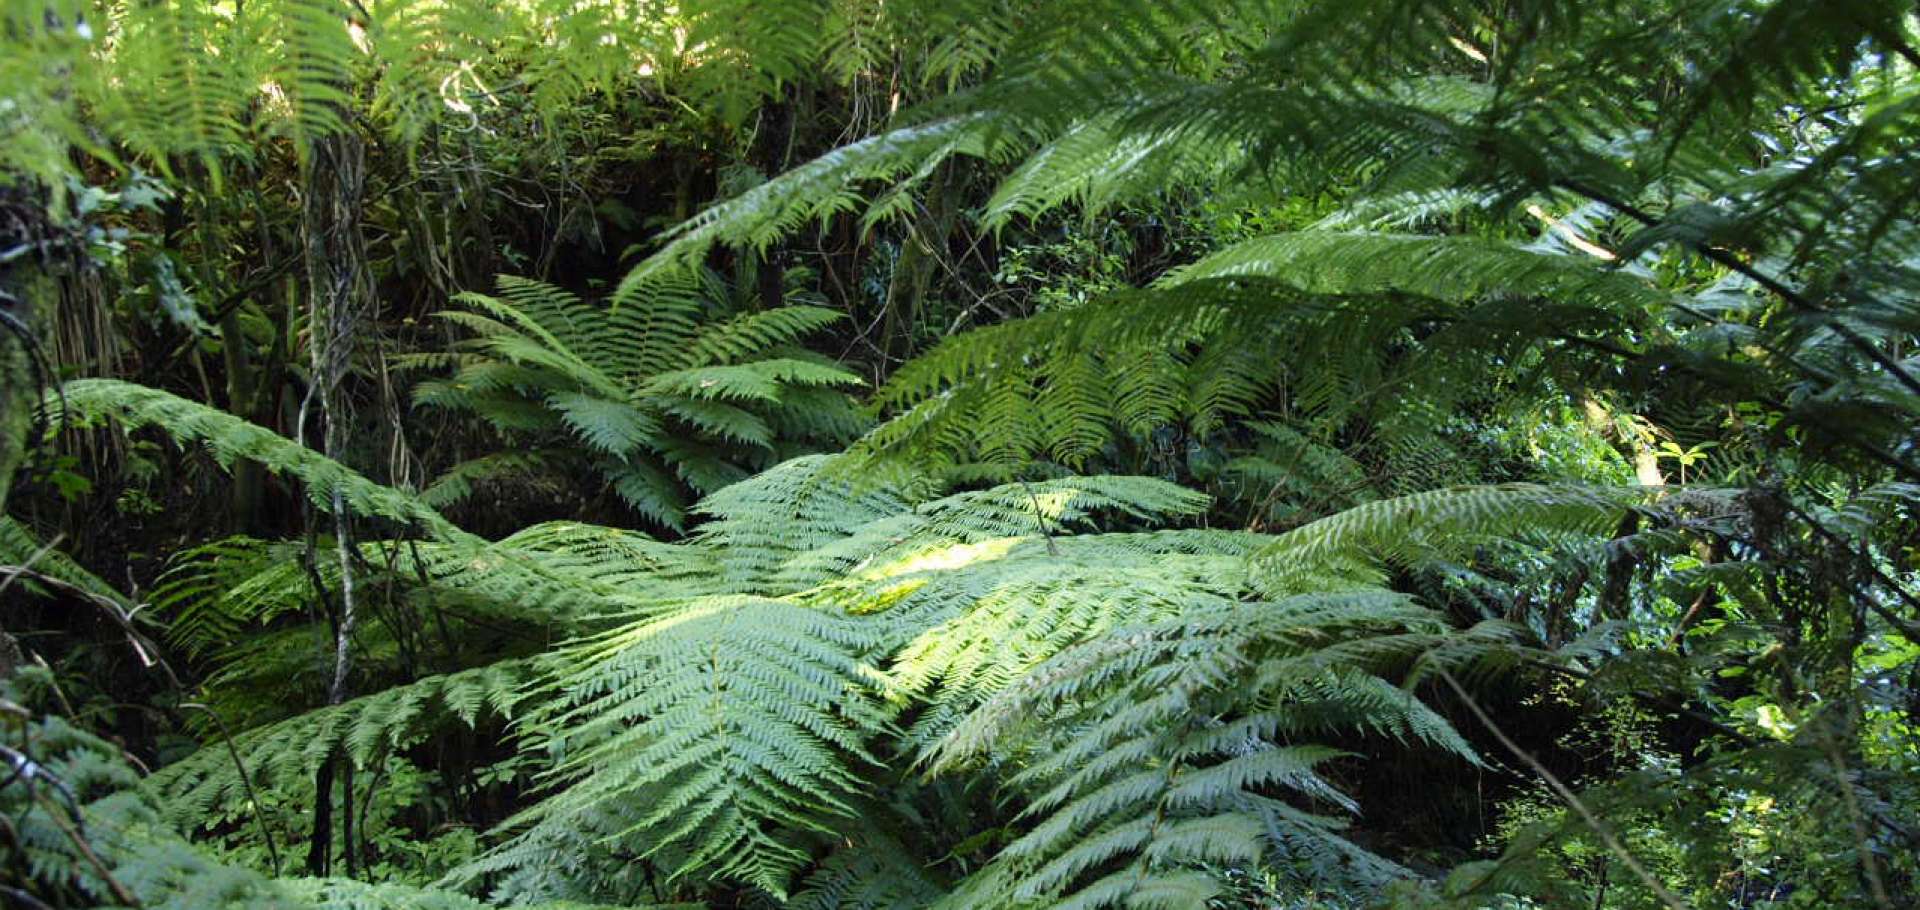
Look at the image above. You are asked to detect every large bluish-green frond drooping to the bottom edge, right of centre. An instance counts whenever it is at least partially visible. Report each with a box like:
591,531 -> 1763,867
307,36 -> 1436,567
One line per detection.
935,593 -> 1473,908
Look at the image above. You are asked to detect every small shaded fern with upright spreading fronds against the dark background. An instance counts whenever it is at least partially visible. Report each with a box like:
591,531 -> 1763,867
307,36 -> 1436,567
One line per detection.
413,275 -> 860,530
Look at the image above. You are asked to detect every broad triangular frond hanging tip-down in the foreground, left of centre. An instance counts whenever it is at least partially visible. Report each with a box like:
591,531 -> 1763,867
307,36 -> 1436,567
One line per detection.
487,597 -> 885,895
